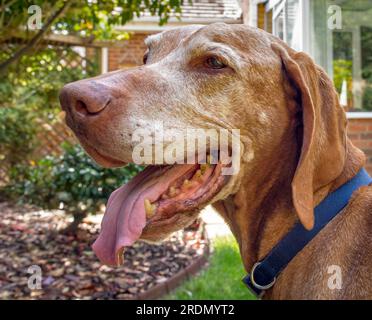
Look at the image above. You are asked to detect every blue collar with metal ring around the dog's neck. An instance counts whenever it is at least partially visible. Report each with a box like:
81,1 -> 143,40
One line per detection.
243,168 -> 372,297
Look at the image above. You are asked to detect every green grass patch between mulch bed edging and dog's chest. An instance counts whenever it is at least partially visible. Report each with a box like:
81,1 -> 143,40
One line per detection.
164,236 -> 255,300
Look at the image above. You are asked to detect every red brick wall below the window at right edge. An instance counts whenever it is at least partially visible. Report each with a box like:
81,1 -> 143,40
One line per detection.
348,119 -> 372,174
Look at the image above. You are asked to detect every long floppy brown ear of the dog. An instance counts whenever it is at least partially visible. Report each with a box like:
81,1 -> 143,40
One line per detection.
272,43 -> 346,230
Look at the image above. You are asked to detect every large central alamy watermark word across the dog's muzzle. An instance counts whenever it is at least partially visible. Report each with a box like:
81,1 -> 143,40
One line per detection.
132,121 -> 240,175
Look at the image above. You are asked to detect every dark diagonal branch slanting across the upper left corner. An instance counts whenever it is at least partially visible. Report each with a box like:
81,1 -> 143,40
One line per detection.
0,1 -> 71,74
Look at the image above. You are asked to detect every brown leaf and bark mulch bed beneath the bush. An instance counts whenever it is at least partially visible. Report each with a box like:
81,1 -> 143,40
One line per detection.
0,202 -> 207,299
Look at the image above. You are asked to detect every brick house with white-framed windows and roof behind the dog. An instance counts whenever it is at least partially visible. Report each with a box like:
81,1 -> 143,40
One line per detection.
102,0 -> 372,173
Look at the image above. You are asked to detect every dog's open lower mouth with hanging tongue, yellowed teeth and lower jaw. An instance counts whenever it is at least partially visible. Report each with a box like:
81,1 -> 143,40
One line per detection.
93,164 -> 225,265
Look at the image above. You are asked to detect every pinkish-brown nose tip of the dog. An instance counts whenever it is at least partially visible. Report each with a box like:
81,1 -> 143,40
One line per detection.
59,81 -> 111,117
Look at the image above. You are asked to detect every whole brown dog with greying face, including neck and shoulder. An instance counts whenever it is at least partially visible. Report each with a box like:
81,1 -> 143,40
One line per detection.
60,23 -> 372,299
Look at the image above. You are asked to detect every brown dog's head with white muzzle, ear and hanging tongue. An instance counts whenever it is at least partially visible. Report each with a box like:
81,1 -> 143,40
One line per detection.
60,23 -> 346,264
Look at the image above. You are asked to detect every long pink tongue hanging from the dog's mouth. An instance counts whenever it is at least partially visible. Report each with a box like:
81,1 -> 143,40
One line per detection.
93,165 -> 195,265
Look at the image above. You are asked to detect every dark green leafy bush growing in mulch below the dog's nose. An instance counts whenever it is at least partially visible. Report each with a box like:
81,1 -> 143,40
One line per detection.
6,144 -> 142,231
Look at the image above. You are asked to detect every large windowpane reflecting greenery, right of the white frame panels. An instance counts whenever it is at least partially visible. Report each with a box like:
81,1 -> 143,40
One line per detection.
310,0 -> 372,111
